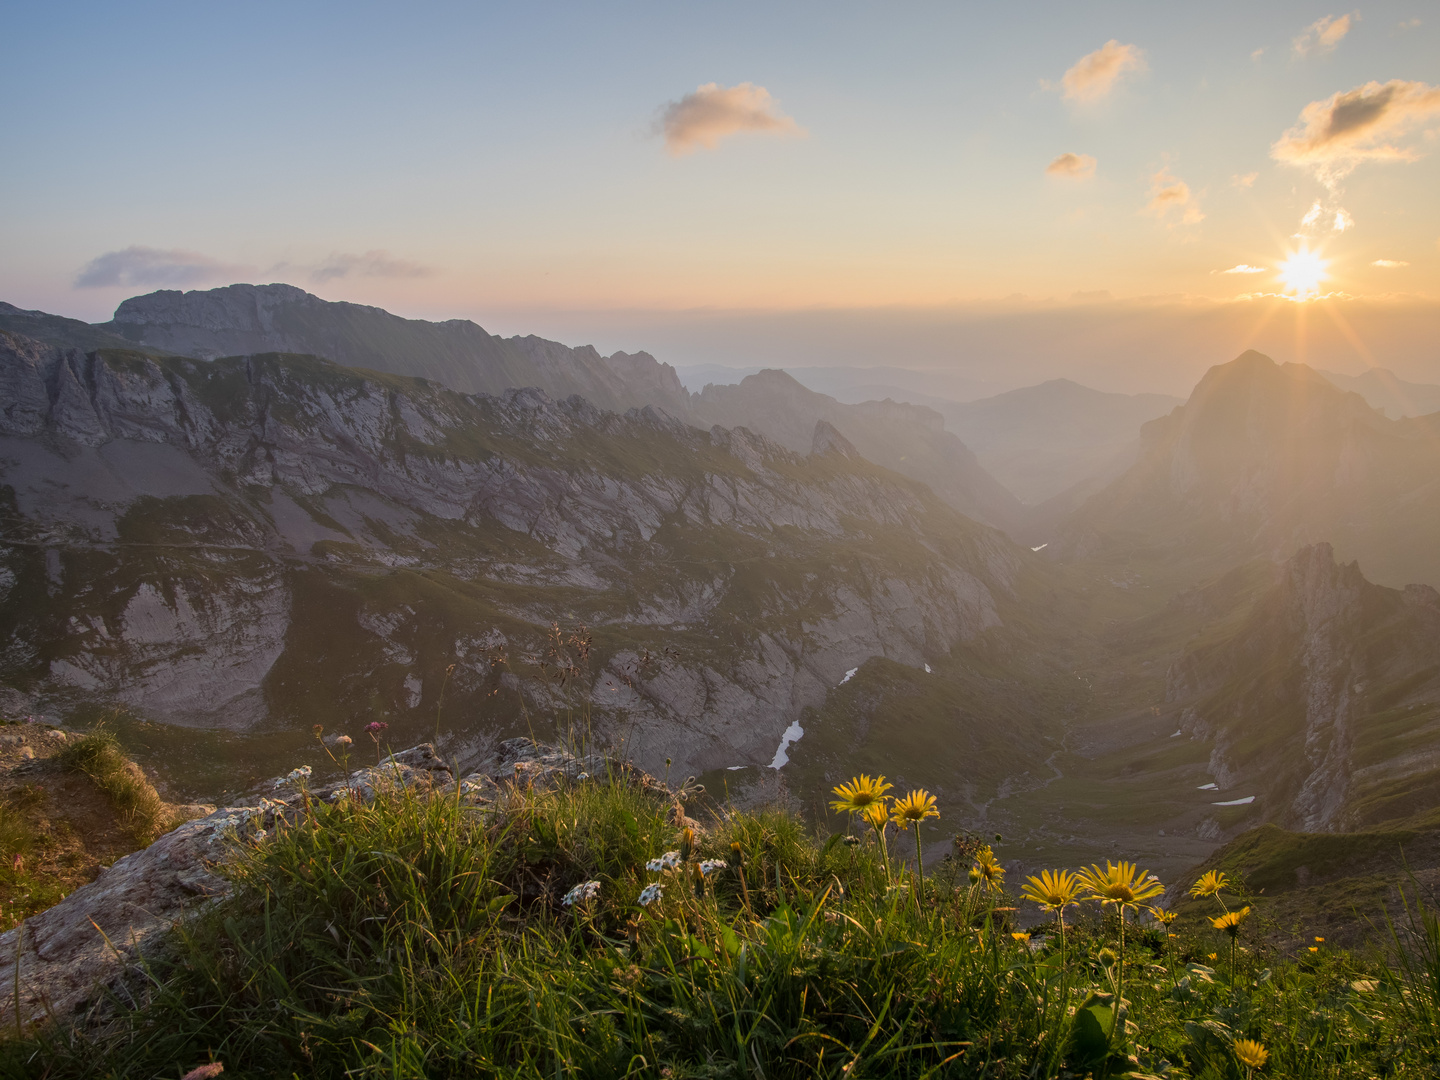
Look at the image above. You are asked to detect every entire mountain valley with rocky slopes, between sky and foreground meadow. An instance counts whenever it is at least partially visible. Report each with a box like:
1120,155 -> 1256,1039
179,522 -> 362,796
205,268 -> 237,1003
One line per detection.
0,287 -> 1440,898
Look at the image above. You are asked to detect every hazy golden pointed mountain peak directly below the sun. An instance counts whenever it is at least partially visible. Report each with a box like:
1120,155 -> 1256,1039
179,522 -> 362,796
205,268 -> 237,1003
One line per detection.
1053,351 -> 1440,588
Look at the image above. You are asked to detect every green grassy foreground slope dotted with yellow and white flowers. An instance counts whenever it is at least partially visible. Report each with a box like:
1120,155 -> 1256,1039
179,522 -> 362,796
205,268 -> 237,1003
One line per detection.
0,778 -> 1440,1080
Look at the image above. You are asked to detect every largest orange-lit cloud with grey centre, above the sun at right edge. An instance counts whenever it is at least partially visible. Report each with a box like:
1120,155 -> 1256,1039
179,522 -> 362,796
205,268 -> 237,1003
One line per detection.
1270,79 -> 1440,183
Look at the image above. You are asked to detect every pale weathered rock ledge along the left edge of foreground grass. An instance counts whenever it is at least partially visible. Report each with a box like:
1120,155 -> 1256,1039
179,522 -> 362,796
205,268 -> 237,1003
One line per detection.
0,739 -> 636,1024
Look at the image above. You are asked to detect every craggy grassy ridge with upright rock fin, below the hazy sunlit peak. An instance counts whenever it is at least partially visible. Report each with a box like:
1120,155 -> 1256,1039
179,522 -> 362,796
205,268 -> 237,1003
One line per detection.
1166,544 -> 1440,832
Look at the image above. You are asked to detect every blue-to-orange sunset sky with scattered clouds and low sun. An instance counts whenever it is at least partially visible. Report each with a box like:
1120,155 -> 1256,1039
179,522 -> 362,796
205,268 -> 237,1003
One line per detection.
0,0 -> 1440,392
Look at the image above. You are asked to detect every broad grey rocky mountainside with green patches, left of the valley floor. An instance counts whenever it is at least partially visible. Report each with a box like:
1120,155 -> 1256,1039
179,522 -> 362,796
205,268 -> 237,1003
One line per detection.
0,334 -> 1030,773
